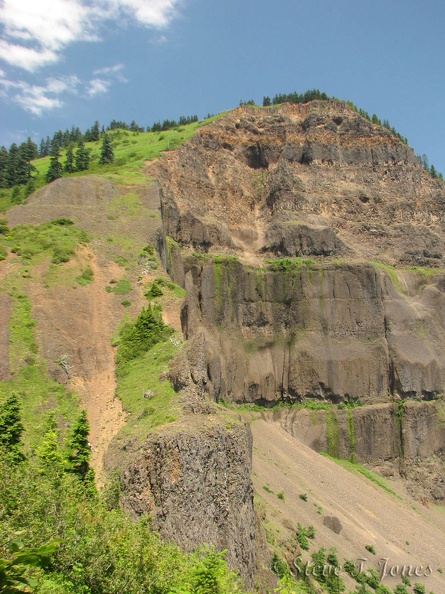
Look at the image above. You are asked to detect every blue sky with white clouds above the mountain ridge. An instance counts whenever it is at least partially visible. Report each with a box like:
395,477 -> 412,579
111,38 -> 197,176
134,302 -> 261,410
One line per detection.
0,0 -> 445,174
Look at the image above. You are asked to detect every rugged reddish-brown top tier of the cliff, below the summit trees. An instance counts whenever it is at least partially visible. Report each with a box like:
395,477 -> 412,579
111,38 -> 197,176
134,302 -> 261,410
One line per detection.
147,101 -> 445,267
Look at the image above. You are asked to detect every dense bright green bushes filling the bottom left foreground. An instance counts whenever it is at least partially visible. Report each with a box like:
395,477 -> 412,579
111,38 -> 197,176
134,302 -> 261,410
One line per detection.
0,432 -> 242,594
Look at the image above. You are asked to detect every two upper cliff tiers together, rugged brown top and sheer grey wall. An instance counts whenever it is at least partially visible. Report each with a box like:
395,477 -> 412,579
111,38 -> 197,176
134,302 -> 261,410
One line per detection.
149,101 -> 445,404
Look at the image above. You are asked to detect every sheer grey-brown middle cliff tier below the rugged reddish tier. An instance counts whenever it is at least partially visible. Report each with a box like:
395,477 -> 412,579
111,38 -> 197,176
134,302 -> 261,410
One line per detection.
168,258 -> 445,405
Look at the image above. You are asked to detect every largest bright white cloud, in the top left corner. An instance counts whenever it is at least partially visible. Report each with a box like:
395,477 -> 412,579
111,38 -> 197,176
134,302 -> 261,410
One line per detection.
0,0 -> 182,72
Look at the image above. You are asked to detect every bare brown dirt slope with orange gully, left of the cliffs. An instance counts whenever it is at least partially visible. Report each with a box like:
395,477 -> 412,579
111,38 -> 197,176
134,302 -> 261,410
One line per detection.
6,176 -> 164,485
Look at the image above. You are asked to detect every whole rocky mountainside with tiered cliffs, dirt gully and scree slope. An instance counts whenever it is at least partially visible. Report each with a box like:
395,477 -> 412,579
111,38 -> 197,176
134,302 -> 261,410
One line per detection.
0,100 -> 445,592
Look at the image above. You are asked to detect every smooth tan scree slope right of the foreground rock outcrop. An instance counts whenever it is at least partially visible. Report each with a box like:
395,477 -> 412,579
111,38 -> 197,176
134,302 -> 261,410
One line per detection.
251,419 -> 445,594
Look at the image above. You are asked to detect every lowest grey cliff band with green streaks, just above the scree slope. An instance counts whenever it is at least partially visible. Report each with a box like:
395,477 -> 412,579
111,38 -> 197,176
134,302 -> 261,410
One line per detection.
263,401 -> 445,502
